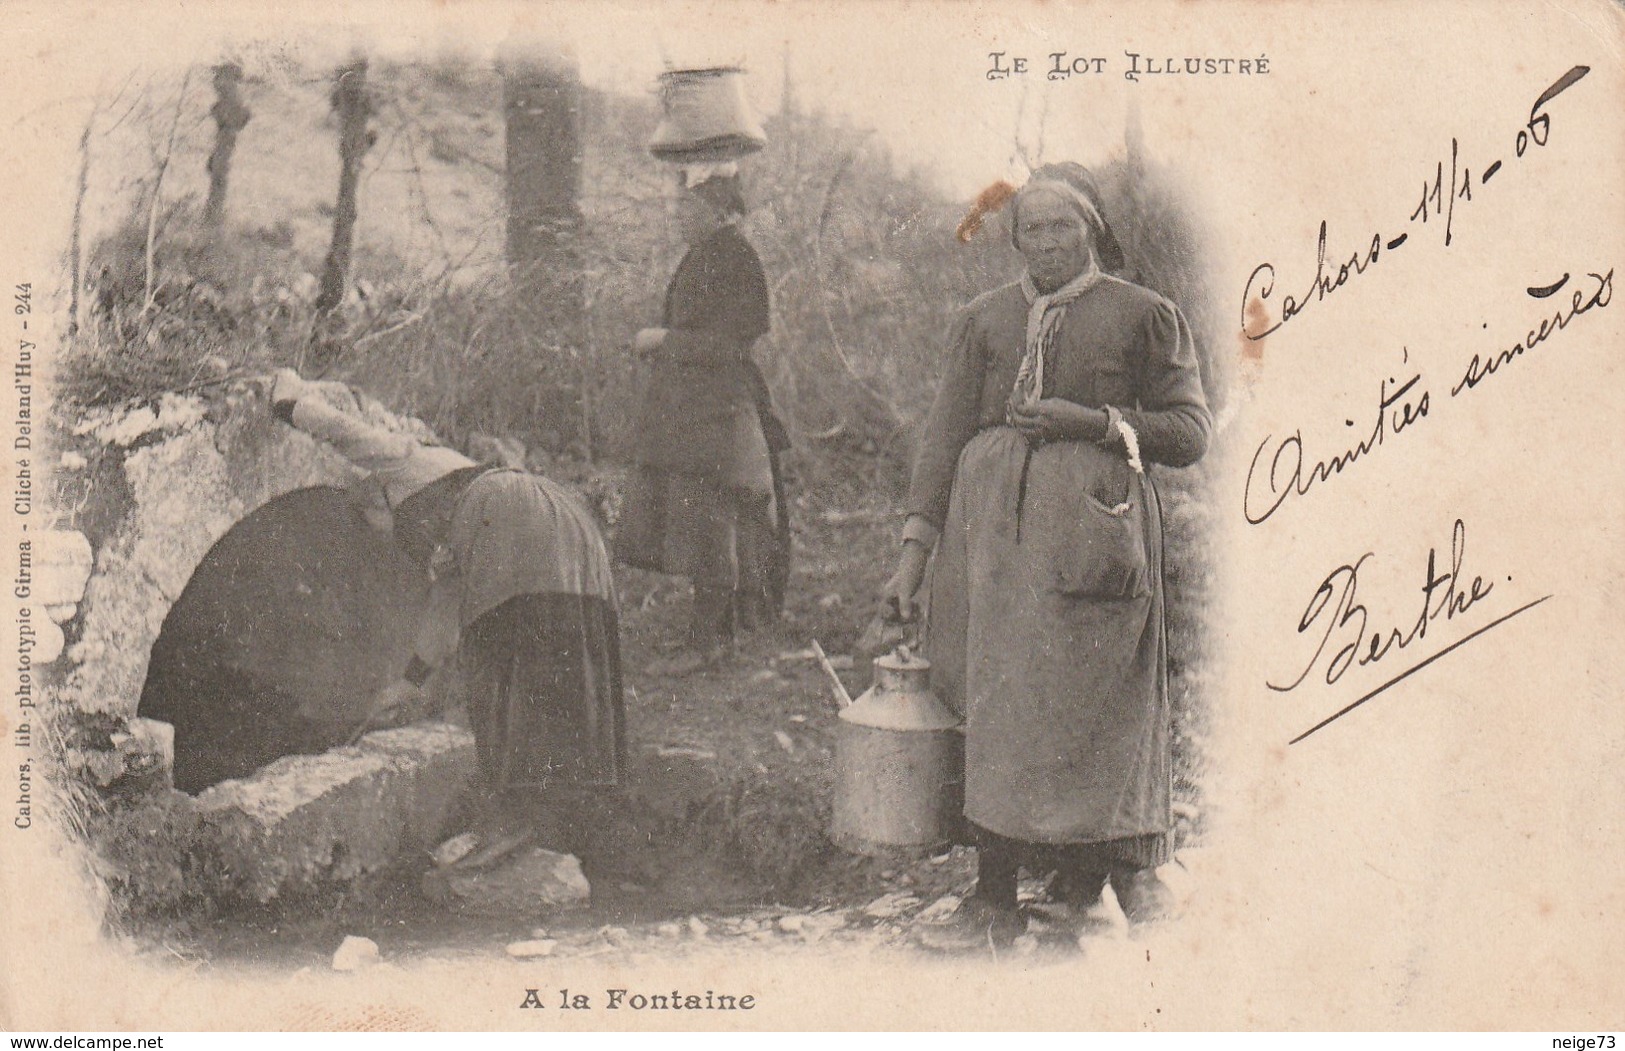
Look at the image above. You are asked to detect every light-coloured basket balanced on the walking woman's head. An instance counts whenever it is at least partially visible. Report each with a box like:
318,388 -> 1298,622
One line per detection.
648,67 -> 767,164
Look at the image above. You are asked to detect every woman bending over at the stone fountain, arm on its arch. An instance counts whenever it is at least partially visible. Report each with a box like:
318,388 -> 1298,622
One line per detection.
271,369 -> 626,866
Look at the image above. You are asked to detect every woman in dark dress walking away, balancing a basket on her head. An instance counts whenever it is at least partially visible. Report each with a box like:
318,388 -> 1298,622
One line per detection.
616,164 -> 788,674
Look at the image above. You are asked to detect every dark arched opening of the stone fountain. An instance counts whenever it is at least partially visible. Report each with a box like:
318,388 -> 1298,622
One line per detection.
138,486 -> 424,793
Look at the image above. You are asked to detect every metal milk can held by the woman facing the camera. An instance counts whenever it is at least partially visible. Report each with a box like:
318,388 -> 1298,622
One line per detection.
832,647 -> 965,854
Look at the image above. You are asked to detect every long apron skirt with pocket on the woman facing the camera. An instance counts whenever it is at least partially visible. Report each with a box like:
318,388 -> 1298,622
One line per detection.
928,427 -> 1172,866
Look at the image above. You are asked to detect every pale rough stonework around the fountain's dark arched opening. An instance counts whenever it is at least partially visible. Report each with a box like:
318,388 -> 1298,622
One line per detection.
36,383 -> 473,913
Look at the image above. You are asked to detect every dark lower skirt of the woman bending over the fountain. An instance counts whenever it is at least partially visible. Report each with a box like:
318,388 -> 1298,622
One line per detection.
462,593 -> 626,791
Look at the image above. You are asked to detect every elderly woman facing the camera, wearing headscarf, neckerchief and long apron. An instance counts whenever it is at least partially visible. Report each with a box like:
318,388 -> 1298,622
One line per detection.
884,164 -> 1211,949
